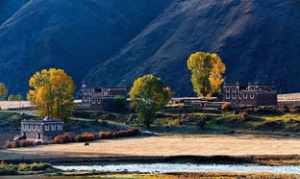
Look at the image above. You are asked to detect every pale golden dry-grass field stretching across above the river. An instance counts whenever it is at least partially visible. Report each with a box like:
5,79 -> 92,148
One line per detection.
0,135 -> 300,160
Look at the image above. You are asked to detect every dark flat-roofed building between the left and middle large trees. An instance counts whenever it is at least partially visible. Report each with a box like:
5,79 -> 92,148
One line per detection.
80,84 -> 128,111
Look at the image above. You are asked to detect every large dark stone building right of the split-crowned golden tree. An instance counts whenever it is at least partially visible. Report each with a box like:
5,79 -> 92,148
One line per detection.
223,83 -> 277,107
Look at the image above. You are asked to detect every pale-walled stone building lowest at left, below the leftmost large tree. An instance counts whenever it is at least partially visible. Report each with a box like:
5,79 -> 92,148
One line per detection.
21,117 -> 64,142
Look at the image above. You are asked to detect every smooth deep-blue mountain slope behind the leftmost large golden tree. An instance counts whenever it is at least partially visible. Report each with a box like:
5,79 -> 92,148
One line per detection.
0,0 -> 168,92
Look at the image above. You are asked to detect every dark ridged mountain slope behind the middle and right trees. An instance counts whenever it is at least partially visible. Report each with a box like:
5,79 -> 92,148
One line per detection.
86,0 -> 300,95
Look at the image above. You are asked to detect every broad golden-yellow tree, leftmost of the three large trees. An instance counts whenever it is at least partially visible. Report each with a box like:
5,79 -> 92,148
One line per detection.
27,68 -> 75,119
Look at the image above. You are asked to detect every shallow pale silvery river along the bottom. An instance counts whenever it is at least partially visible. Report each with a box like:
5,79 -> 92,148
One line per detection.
54,163 -> 300,174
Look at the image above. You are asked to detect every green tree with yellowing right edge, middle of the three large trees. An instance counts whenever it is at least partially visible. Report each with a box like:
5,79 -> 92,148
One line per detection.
130,75 -> 172,128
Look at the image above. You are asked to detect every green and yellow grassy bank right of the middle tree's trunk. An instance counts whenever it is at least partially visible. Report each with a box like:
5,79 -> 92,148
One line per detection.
152,112 -> 300,136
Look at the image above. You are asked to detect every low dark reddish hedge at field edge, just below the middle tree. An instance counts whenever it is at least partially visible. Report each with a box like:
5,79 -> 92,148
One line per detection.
99,129 -> 140,139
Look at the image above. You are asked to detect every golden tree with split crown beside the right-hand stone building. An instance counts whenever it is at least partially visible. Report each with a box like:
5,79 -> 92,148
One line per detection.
187,52 -> 226,97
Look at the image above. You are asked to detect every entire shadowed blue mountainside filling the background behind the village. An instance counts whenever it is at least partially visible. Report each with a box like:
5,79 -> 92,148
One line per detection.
0,0 -> 300,95
